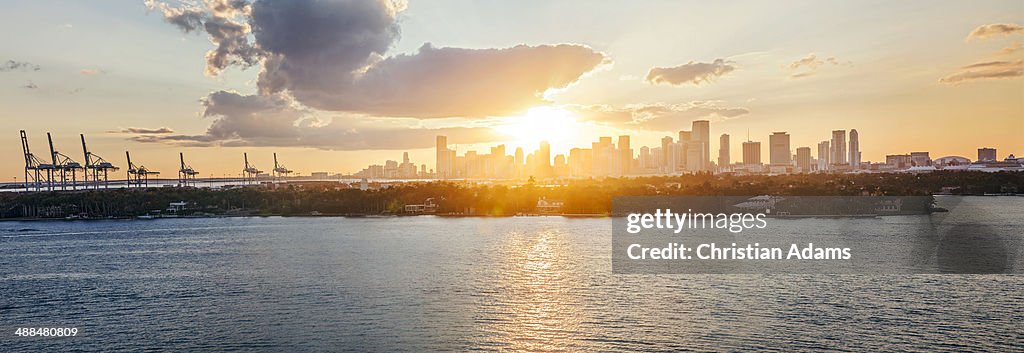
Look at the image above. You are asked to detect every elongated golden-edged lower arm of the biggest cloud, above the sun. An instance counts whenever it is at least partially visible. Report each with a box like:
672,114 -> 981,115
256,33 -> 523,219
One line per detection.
291,43 -> 606,118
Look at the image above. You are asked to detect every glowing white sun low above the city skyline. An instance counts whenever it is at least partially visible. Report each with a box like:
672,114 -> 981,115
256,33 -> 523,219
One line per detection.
495,105 -> 580,147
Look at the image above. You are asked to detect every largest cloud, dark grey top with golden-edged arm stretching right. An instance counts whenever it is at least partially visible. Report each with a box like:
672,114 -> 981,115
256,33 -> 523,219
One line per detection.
146,0 -> 608,118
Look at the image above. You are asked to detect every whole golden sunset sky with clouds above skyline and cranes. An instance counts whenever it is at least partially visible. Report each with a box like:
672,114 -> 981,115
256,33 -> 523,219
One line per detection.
0,0 -> 1024,181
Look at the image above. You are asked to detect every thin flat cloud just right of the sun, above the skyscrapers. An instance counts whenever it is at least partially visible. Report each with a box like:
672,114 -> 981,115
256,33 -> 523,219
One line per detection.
565,101 -> 751,131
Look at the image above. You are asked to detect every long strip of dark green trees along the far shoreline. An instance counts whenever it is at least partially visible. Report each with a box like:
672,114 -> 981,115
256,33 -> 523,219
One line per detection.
0,172 -> 1024,218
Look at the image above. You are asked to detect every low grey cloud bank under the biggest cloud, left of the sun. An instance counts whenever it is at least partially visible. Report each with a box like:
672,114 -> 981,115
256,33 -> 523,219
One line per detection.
131,91 -> 503,150
